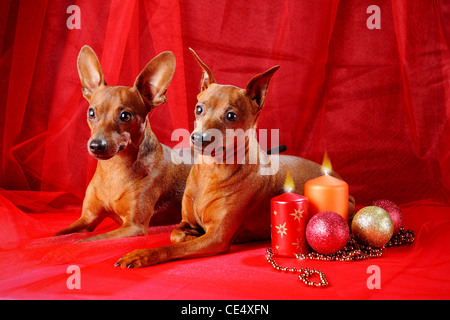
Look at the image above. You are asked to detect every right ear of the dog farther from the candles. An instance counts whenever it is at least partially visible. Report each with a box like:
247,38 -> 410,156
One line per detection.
134,51 -> 176,110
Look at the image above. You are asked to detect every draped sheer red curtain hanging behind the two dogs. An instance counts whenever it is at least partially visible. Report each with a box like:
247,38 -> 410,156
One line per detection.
1,1 -> 450,203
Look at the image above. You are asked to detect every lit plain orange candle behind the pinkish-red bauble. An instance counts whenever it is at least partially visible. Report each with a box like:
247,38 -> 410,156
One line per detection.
305,153 -> 348,221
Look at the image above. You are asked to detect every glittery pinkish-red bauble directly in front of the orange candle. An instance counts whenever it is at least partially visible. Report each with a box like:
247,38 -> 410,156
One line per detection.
306,211 -> 350,254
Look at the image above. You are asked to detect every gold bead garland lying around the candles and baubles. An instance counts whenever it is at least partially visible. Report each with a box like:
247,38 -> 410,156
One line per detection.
266,228 -> 414,287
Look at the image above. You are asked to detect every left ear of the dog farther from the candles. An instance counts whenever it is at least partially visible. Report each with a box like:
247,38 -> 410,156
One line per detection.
77,45 -> 106,101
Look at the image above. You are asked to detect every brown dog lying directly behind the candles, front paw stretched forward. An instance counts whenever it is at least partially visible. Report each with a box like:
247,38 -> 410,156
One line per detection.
116,51 -> 355,268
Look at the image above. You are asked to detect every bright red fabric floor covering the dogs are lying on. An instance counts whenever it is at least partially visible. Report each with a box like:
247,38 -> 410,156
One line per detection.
0,197 -> 450,300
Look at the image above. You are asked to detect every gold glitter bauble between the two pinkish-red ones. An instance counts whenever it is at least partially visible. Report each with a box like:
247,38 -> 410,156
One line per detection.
352,206 -> 394,248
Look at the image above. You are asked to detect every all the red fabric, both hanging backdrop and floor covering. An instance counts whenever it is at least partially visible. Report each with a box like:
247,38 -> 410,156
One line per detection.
0,0 -> 450,298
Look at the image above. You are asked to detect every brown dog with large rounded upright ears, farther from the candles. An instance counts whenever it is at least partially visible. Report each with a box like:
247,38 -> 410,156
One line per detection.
55,46 -> 192,241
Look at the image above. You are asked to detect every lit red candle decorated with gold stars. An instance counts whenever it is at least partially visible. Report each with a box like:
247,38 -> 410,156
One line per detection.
270,173 -> 309,257
